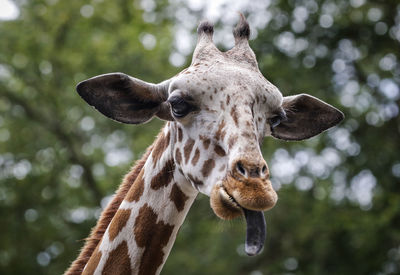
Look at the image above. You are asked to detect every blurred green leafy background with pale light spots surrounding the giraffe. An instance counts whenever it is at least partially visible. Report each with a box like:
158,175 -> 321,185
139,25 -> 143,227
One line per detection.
0,0 -> 400,275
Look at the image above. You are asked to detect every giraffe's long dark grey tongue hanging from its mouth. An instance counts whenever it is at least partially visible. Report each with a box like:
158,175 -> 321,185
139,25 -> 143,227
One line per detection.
243,208 -> 267,256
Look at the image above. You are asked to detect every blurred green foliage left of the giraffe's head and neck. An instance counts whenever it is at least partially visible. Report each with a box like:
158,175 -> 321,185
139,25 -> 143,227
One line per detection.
0,1 -> 172,274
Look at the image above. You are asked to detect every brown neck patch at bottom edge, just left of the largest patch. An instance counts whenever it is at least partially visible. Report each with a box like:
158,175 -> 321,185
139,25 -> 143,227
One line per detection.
102,241 -> 132,275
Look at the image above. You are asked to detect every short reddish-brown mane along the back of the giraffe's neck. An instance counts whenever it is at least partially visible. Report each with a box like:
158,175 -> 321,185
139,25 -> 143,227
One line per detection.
64,145 -> 153,275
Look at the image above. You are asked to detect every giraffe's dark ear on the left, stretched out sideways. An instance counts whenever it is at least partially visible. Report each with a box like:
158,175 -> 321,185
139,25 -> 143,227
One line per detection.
76,73 -> 173,124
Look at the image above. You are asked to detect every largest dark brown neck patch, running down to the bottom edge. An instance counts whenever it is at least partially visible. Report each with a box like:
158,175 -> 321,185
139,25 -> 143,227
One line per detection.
133,203 -> 174,275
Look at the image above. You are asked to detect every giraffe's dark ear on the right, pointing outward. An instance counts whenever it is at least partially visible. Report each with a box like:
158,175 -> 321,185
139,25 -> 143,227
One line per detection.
271,94 -> 344,140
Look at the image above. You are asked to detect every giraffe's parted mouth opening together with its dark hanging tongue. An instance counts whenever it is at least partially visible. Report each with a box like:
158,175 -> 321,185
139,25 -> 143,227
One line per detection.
219,184 -> 267,256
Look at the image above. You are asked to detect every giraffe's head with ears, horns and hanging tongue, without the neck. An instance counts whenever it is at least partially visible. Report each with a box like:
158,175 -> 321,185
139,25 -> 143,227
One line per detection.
77,16 -> 343,255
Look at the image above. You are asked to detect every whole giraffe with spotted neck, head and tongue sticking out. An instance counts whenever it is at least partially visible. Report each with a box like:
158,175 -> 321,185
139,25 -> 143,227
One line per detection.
65,14 -> 344,275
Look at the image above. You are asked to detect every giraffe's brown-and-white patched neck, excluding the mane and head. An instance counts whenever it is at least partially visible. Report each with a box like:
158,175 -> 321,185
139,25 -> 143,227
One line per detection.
83,123 -> 197,275
